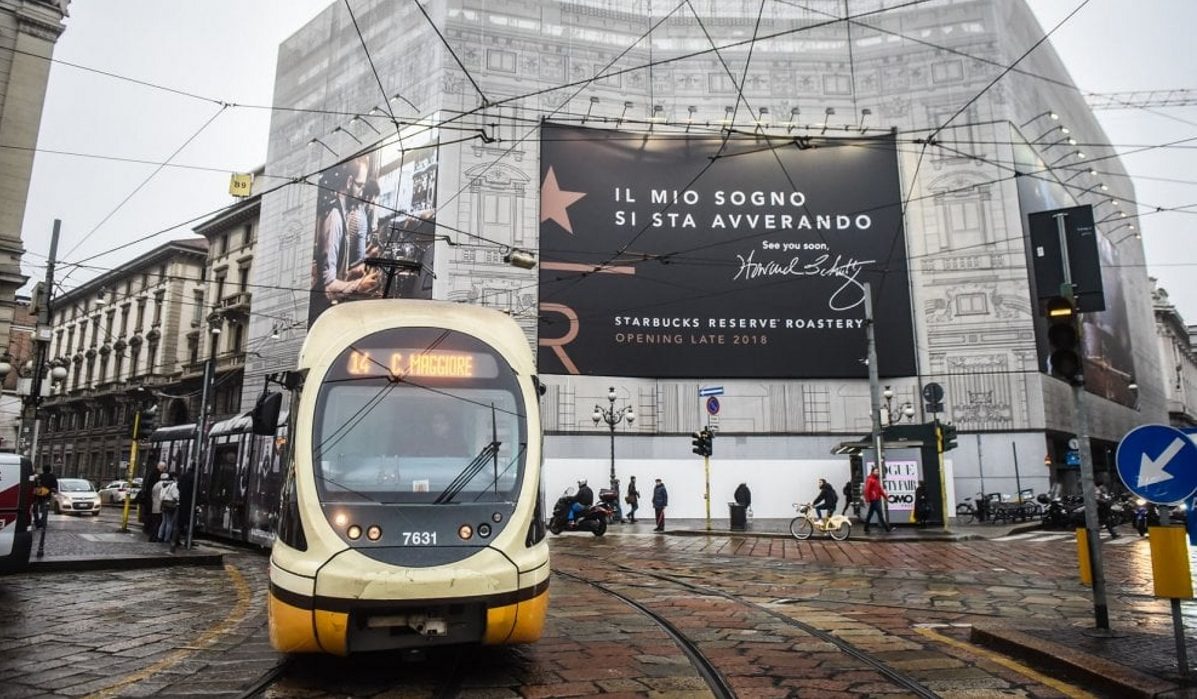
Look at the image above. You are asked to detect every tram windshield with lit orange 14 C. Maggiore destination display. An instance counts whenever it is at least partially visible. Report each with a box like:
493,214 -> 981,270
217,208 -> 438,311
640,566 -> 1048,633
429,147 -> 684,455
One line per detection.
312,328 -> 528,505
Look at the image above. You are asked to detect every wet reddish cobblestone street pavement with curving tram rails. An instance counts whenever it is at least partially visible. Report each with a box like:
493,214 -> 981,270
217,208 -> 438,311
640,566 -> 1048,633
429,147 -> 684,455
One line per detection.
0,521 -> 1193,699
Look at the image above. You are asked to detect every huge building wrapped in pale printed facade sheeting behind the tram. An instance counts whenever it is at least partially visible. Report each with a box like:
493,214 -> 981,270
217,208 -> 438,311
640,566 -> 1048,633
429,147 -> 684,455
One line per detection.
244,0 -> 1166,516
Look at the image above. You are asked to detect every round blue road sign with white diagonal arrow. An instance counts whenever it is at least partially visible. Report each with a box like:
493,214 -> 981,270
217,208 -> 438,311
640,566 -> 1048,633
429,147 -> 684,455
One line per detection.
1114,425 -> 1197,505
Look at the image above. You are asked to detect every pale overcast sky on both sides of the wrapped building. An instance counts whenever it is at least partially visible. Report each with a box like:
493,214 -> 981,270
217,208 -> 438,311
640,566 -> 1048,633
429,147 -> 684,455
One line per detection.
23,0 -> 1197,315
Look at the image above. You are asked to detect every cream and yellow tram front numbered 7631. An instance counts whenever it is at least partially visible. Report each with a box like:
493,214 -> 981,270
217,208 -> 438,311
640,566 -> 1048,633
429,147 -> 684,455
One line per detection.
269,300 -> 548,655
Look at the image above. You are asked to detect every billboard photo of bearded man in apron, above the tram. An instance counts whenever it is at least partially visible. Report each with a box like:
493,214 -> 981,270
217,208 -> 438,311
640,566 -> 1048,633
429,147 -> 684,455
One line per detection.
308,129 -> 437,324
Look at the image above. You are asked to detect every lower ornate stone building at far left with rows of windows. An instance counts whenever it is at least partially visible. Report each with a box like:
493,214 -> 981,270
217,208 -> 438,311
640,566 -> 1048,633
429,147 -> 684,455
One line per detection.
36,238 -> 208,481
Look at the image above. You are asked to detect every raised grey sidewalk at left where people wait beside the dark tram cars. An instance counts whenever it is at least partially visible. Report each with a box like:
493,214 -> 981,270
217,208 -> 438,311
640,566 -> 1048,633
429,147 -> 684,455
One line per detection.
22,507 -> 224,573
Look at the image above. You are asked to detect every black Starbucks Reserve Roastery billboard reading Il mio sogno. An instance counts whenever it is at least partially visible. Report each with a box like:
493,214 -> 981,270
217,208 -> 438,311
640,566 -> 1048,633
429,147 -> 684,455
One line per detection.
539,123 -> 915,378
